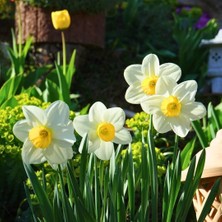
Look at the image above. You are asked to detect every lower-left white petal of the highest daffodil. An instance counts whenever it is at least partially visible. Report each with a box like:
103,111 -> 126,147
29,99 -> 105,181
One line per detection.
125,82 -> 149,104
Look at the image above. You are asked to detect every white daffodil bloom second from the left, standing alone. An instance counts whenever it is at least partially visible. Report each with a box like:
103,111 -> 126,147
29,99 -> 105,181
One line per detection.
73,102 -> 132,160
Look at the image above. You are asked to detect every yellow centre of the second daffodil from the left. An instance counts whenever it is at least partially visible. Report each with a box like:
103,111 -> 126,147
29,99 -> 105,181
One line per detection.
97,123 -> 115,142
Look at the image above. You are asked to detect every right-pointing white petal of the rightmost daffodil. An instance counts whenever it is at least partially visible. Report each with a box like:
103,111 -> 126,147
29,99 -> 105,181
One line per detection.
182,102 -> 206,121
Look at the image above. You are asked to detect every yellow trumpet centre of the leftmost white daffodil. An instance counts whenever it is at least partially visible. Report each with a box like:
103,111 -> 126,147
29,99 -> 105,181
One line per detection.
29,126 -> 52,149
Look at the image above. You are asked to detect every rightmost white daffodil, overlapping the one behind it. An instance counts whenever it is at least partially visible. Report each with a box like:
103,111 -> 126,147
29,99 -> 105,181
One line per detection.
141,80 -> 206,137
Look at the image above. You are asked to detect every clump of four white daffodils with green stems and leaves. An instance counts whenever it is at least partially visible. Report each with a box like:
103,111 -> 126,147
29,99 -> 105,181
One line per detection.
13,54 -> 222,222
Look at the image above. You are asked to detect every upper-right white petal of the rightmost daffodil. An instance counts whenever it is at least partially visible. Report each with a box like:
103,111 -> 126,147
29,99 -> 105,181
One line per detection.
173,80 -> 197,103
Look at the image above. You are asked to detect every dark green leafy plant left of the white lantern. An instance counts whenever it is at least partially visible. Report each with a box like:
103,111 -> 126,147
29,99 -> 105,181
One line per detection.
173,14 -> 218,84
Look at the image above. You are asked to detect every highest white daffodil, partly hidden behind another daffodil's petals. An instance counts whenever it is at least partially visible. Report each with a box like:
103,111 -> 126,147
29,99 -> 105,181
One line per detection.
124,54 -> 181,104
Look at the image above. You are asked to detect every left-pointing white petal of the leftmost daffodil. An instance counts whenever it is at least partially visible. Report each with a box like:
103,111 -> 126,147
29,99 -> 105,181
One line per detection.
13,120 -> 32,142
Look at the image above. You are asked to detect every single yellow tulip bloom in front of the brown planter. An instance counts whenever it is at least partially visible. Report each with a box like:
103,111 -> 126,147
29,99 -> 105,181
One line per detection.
51,9 -> 71,30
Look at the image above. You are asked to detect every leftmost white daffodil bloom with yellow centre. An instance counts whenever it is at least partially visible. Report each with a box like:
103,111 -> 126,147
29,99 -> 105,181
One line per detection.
13,101 -> 76,168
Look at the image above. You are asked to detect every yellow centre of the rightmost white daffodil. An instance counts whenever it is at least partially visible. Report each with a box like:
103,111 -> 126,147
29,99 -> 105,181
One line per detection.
161,96 -> 181,117
